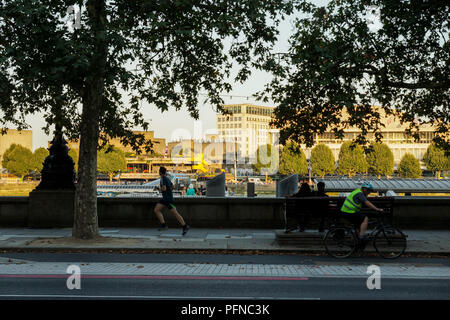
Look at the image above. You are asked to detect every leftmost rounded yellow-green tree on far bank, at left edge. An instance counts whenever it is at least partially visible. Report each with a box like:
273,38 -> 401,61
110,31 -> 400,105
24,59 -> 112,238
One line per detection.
2,144 -> 34,179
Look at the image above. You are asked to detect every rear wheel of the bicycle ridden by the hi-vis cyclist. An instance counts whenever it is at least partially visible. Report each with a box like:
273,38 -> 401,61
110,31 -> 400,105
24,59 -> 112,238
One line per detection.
324,227 -> 358,258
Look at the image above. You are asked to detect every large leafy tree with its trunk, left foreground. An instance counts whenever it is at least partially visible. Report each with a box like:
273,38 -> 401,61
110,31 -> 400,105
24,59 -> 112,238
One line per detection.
0,0 -> 293,239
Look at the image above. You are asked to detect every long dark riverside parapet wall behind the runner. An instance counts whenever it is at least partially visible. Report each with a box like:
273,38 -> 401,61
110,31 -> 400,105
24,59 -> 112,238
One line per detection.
0,197 -> 450,230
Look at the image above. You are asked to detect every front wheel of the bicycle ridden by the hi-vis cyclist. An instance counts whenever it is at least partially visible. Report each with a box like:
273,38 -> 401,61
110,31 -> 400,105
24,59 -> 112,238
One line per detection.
373,227 -> 406,259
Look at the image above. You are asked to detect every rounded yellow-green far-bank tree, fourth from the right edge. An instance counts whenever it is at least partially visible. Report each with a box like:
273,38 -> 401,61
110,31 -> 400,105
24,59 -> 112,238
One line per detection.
337,141 -> 368,178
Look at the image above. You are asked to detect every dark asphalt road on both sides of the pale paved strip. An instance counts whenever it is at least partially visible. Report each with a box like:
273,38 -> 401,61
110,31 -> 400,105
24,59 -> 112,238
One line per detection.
0,253 -> 450,301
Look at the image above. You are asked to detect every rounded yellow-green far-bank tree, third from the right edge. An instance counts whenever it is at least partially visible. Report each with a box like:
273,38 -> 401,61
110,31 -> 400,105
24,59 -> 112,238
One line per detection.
366,143 -> 394,178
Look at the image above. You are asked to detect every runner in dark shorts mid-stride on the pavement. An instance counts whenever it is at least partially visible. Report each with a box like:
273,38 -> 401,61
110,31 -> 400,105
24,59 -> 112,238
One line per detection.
155,167 -> 189,236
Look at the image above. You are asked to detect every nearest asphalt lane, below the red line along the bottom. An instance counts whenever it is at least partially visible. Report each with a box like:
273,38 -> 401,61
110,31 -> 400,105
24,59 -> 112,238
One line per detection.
0,277 -> 450,300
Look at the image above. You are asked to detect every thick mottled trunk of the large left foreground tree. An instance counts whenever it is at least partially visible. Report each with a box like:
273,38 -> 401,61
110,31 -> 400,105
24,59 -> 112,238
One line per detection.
72,0 -> 107,239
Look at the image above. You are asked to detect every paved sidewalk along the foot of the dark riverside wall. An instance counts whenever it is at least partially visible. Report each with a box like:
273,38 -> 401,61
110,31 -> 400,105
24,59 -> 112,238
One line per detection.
0,228 -> 450,254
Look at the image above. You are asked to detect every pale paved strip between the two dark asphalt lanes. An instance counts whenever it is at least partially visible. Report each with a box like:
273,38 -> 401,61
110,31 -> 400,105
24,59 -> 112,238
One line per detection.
0,259 -> 450,280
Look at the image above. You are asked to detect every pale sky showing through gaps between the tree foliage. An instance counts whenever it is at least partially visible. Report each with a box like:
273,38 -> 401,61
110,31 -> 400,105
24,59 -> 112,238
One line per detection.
19,1 -> 327,150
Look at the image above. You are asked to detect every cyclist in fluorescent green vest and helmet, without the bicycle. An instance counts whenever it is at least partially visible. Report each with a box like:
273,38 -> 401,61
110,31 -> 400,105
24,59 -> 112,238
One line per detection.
341,182 -> 383,240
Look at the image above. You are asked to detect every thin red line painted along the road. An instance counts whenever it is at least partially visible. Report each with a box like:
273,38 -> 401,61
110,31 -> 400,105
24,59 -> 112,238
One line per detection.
0,274 -> 309,281
